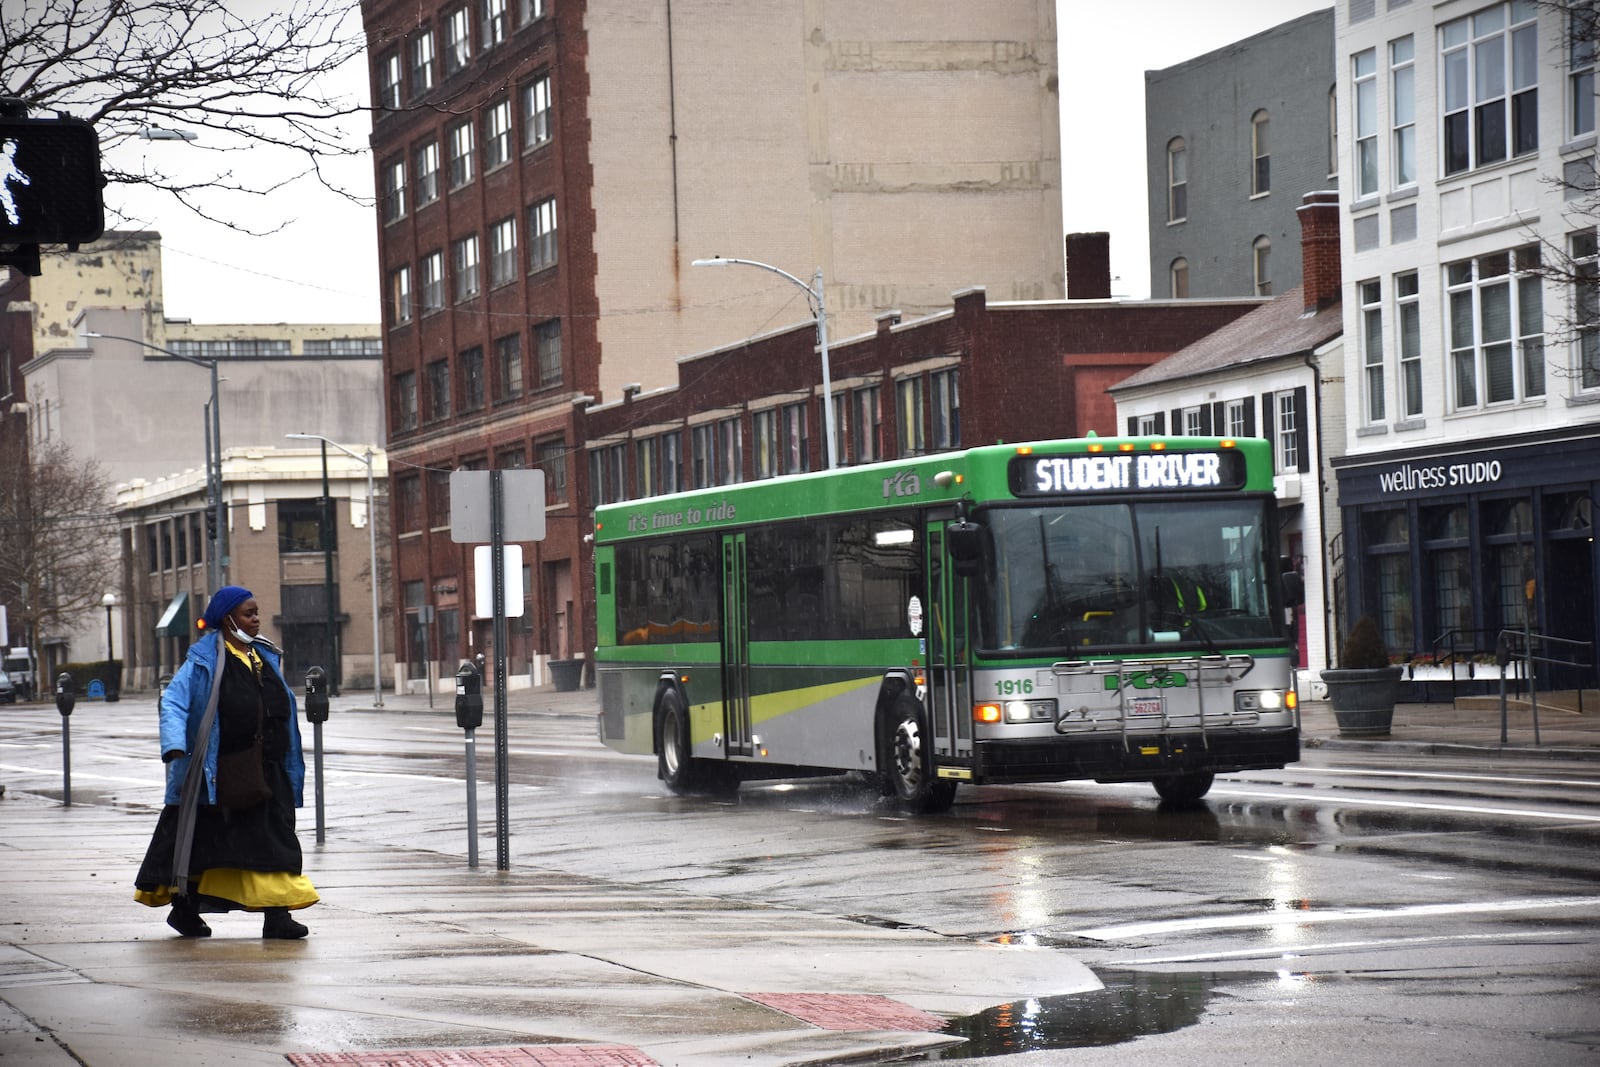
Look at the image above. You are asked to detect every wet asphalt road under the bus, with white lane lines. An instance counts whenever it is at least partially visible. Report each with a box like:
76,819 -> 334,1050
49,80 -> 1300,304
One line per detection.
0,702 -> 1600,1067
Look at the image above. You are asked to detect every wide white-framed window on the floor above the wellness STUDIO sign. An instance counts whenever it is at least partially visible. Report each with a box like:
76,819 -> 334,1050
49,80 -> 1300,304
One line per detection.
1445,245 -> 1544,411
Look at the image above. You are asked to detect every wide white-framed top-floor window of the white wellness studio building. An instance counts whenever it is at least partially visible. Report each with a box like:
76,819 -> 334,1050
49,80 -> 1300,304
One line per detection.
1440,0 -> 1539,174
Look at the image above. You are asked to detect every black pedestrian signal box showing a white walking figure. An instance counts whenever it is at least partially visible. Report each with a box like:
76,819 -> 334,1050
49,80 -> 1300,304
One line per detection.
0,115 -> 106,245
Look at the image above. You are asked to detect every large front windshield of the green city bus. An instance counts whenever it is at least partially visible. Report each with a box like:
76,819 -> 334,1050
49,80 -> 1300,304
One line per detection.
979,499 -> 1283,656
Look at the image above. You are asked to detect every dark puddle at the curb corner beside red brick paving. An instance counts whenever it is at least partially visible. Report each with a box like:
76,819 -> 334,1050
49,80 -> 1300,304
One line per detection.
914,971 -> 1224,1062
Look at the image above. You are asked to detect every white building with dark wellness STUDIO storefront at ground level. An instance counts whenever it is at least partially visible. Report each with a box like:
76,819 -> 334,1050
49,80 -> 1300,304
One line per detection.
1331,0 -> 1600,685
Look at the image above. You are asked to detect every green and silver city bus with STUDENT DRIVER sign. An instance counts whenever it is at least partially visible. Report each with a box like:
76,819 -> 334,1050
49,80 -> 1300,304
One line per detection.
594,437 -> 1299,811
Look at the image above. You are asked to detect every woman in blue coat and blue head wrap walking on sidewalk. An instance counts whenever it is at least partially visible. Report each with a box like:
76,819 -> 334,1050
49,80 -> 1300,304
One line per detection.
134,585 -> 318,939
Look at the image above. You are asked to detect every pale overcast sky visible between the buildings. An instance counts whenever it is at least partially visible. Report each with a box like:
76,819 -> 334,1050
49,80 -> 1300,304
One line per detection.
110,0 -> 1331,323
